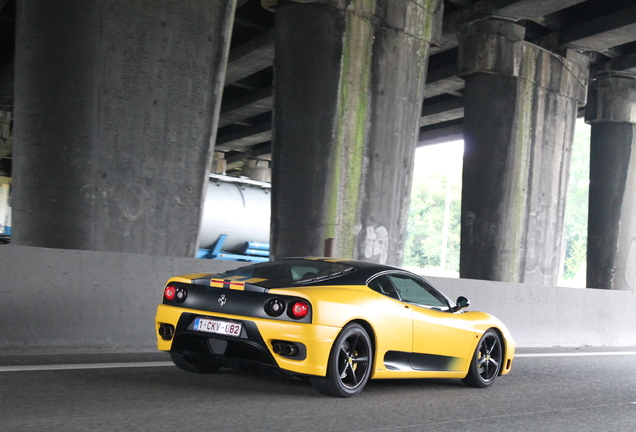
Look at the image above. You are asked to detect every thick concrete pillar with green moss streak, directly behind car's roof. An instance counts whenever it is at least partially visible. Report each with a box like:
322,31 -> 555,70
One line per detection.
263,0 -> 443,264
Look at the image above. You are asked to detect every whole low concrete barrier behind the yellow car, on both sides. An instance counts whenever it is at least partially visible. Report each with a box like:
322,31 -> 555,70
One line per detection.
0,245 -> 636,354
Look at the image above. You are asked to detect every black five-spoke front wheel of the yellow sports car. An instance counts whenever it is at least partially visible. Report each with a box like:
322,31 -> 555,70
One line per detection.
463,329 -> 503,388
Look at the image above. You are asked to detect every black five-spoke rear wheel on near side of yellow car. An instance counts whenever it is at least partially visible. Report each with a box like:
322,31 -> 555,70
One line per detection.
310,323 -> 373,398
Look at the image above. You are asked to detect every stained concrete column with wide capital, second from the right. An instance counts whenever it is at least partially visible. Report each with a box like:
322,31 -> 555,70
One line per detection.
459,20 -> 588,285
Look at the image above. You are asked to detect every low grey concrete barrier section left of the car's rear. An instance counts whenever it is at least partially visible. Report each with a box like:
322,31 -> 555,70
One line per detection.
0,245 -> 237,354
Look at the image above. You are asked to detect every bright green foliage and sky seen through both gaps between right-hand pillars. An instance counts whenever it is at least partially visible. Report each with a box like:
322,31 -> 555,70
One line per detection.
404,119 -> 590,280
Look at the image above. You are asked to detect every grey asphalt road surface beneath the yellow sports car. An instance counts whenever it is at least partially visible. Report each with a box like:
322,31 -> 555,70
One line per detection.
0,348 -> 636,432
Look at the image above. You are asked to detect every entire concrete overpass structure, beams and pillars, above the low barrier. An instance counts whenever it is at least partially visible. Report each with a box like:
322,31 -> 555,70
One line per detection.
0,0 -> 636,290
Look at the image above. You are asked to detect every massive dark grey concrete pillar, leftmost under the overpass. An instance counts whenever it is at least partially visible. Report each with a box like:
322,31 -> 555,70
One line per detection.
12,0 -> 236,256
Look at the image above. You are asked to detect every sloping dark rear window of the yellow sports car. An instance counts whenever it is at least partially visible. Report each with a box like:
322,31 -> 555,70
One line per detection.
212,259 -> 354,288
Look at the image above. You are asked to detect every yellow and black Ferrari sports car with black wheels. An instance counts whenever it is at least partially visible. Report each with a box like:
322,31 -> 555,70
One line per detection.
156,258 -> 515,397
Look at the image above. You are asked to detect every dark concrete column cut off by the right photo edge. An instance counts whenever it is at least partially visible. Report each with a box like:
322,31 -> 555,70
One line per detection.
585,74 -> 636,291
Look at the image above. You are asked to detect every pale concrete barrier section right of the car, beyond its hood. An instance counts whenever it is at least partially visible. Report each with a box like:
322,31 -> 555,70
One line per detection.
426,277 -> 636,347
